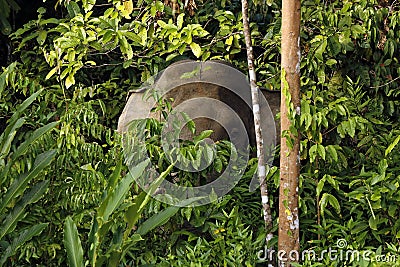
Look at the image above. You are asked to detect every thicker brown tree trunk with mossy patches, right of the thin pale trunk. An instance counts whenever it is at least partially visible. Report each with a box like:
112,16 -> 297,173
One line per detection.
278,0 -> 301,266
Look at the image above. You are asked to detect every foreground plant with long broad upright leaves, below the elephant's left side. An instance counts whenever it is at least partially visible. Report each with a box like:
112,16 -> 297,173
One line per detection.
64,160 -> 200,266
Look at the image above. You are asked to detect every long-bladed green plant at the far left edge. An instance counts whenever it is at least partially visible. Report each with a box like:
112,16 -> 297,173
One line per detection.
0,89 -> 56,266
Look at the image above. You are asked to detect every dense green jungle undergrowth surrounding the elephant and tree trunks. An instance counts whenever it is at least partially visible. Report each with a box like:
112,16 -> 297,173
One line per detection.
0,0 -> 400,266
